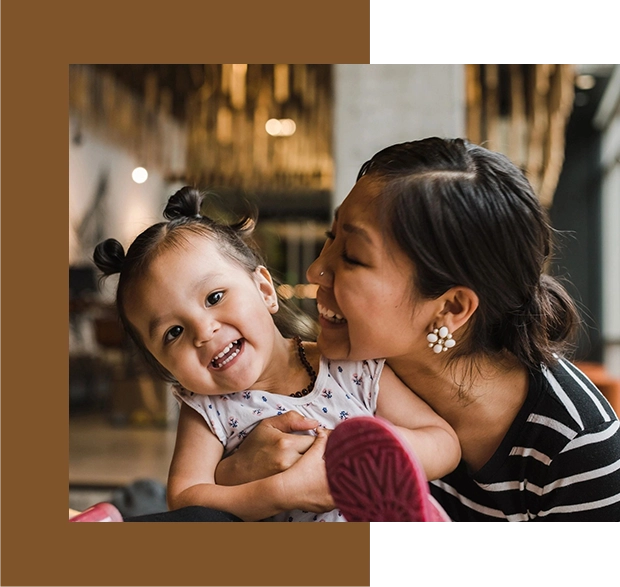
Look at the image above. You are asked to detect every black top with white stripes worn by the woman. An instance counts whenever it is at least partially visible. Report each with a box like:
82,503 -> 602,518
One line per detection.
431,360 -> 620,528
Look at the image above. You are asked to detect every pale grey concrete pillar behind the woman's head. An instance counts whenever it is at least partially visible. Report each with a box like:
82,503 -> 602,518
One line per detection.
333,63 -> 465,206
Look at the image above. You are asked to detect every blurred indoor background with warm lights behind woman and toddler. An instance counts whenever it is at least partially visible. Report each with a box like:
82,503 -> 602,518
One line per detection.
69,64 -> 620,515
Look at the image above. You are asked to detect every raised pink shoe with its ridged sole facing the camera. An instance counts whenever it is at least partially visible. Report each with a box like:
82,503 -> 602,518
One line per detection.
325,416 -> 450,522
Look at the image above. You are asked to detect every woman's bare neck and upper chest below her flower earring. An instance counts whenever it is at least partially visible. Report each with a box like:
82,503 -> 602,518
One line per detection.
388,358 -> 529,470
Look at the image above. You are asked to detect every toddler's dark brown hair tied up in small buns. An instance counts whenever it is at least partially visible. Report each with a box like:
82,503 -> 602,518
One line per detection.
93,186 -> 317,383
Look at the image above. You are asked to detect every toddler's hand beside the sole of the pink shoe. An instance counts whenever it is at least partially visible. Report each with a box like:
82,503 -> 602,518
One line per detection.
282,428 -> 336,513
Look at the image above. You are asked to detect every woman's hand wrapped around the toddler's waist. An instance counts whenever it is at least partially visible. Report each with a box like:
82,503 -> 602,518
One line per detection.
215,412 -> 322,485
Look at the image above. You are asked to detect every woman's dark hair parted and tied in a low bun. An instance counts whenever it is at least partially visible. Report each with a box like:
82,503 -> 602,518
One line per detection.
358,137 -> 579,370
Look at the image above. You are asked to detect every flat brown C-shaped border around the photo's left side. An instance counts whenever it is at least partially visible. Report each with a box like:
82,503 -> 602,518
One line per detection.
3,0 -> 370,587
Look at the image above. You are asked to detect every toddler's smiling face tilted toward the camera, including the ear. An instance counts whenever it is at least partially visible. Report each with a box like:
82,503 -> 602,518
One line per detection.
126,235 -> 277,395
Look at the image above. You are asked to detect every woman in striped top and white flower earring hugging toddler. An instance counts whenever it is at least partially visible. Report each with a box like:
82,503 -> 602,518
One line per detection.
220,138 -> 620,527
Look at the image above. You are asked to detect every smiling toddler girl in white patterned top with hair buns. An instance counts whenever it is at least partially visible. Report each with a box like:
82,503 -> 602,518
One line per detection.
94,187 -> 460,521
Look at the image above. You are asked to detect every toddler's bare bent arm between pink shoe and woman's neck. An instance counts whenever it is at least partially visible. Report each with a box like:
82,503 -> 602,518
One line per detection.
376,364 -> 461,480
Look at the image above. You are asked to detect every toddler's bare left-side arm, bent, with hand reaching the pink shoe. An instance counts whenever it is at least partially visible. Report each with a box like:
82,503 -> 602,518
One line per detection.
168,404 -> 334,521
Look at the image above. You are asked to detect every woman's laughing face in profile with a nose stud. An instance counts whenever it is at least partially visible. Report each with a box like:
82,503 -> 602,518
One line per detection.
307,176 -> 432,360
